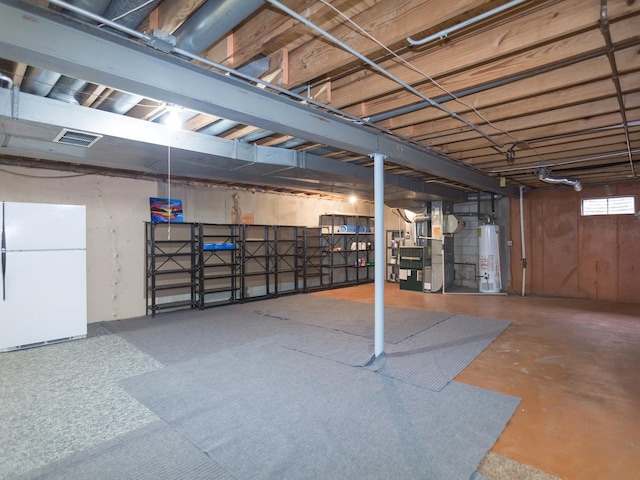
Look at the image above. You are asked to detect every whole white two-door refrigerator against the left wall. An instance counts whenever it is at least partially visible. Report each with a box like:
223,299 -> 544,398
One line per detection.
0,202 -> 87,352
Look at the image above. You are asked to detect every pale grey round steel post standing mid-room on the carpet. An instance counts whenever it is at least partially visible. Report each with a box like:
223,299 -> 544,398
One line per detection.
373,153 -> 385,357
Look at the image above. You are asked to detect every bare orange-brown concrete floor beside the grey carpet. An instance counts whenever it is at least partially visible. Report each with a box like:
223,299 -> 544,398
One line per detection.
316,284 -> 640,480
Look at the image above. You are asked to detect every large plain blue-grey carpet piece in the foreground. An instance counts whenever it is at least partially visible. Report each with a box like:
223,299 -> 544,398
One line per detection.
121,339 -> 519,480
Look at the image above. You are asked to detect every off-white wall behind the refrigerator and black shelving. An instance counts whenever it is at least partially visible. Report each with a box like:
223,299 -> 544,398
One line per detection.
0,165 -> 398,322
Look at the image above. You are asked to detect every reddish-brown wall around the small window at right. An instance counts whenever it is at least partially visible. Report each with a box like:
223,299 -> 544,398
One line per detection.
510,182 -> 640,303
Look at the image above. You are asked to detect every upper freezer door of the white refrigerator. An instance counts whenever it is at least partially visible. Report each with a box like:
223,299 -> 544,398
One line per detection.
4,202 -> 87,251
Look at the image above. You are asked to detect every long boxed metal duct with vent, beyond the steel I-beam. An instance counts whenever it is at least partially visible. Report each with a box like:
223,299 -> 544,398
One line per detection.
0,89 -> 464,201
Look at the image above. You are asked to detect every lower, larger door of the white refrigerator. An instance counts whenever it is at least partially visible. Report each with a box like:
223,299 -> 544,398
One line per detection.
0,250 -> 87,351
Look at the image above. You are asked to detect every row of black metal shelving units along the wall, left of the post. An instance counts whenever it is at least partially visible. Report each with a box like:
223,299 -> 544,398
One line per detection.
145,215 -> 374,315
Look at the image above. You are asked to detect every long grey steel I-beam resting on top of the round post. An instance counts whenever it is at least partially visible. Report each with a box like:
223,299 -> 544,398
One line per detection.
0,0 -> 518,197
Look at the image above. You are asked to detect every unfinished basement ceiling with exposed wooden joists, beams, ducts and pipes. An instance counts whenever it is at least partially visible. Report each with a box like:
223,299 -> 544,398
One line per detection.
0,0 -> 640,203
